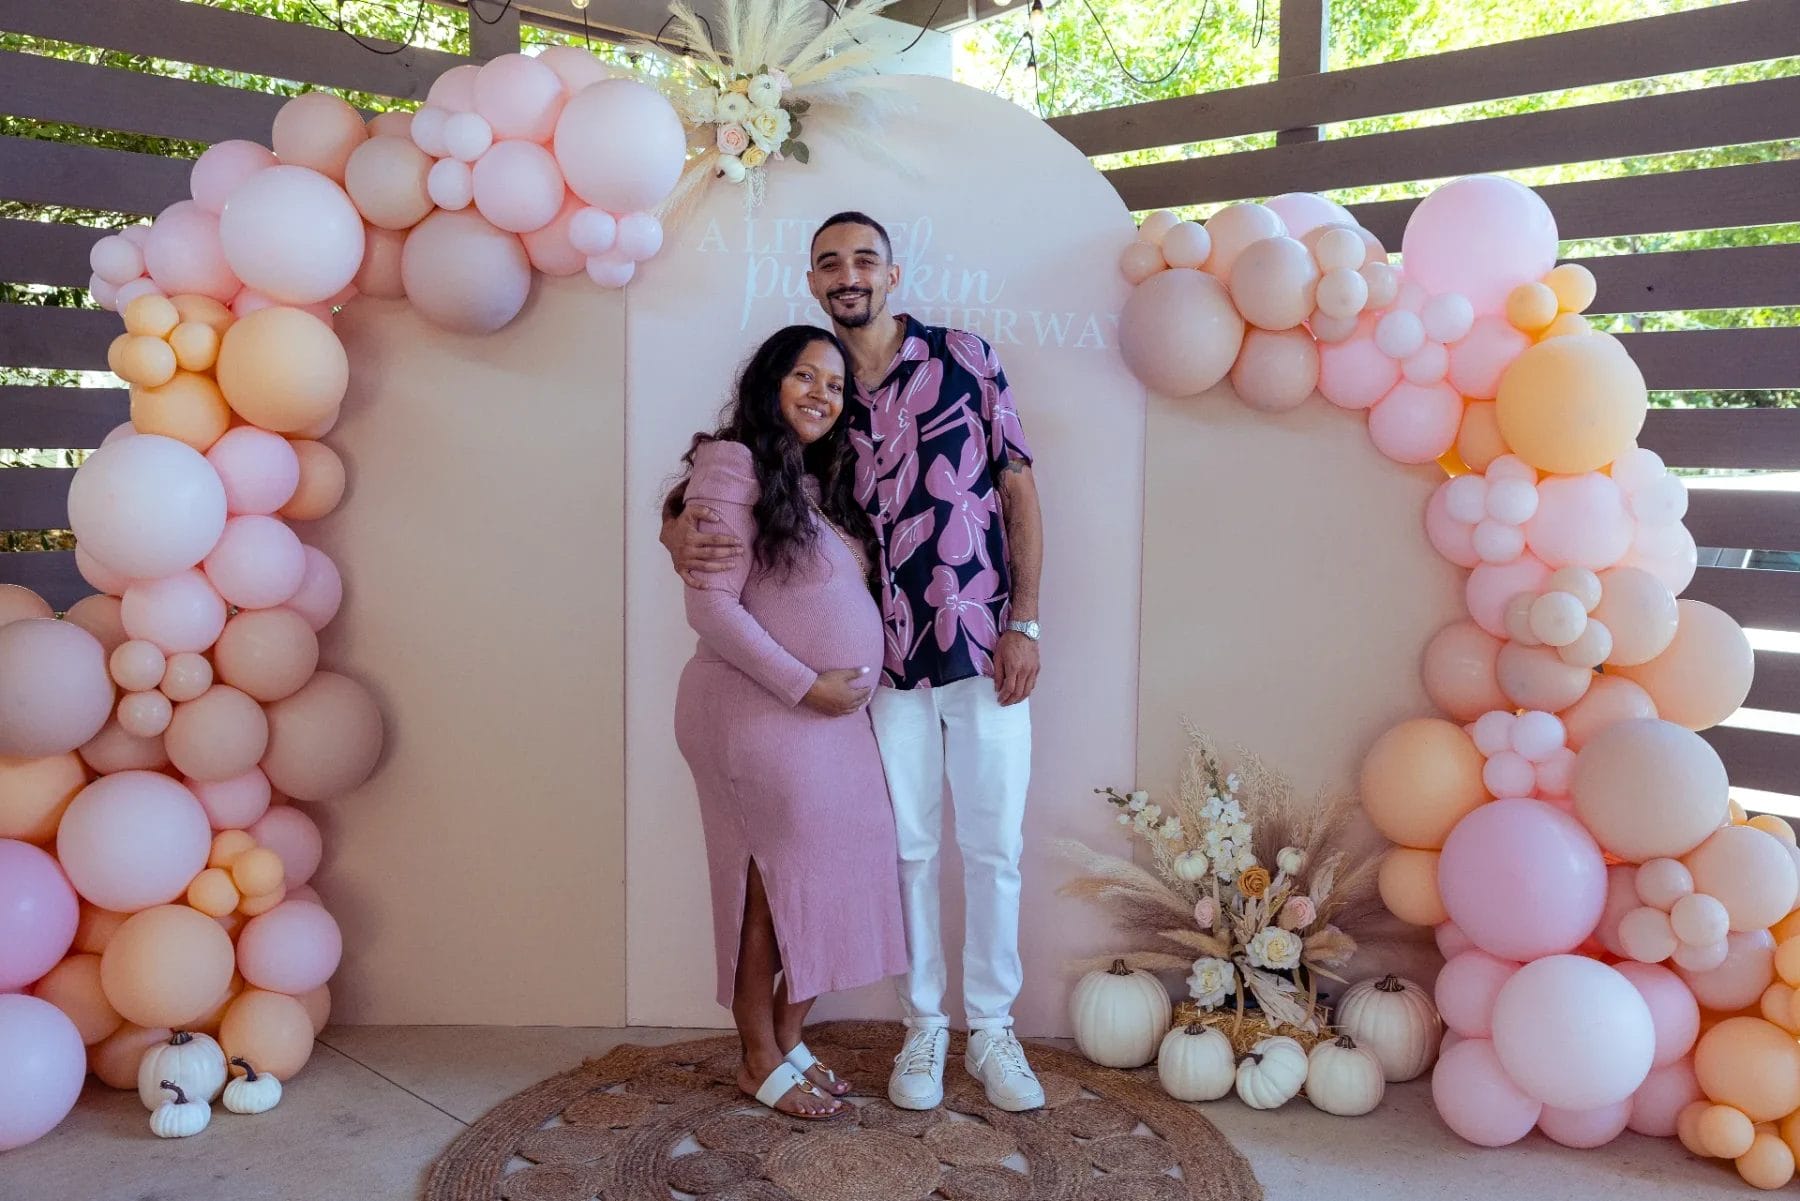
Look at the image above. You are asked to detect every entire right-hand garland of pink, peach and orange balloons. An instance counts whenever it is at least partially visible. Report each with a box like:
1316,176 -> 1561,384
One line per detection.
1120,176 -> 1800,1188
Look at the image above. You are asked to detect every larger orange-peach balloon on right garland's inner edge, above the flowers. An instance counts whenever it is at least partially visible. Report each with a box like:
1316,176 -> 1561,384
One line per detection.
1361,718 -> 1489,850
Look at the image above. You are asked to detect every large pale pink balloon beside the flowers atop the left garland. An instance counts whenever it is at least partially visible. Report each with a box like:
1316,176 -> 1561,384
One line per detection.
554,79 -> 688,212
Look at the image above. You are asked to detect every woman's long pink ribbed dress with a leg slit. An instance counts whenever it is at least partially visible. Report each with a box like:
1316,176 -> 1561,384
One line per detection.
675,441 -> 907,1007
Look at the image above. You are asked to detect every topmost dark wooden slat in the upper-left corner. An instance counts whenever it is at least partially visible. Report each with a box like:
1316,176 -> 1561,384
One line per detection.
0,0 -> 470,99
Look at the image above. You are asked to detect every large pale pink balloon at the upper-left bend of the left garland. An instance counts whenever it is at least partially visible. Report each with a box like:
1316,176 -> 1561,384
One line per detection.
220,164 -> 364,304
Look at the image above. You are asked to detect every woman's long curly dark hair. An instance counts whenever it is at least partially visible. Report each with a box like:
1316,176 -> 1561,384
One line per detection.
670,326 -> 877,573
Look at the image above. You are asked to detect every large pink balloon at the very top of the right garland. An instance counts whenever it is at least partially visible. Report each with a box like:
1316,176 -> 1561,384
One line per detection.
1400,175 -> 1557,313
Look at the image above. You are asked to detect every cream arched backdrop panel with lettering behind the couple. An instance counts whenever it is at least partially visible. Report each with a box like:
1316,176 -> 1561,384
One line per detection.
626,76 -> 1143,1034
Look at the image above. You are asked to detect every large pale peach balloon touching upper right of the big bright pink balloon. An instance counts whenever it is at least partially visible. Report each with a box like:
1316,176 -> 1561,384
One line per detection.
1573,718 -> 1728,862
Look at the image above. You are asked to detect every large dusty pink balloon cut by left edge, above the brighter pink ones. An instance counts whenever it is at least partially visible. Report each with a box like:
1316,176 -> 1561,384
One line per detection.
0,618 -> 113,758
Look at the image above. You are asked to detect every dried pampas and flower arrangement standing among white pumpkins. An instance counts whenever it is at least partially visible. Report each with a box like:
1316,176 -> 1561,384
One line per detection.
1058,722 -> 1381,1035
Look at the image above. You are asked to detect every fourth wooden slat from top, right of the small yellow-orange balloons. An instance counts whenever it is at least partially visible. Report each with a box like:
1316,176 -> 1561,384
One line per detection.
1579,244 -> 1800,313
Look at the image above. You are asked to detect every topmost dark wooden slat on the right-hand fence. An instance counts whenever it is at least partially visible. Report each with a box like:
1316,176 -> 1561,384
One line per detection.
1049,0 -> 1800,155
